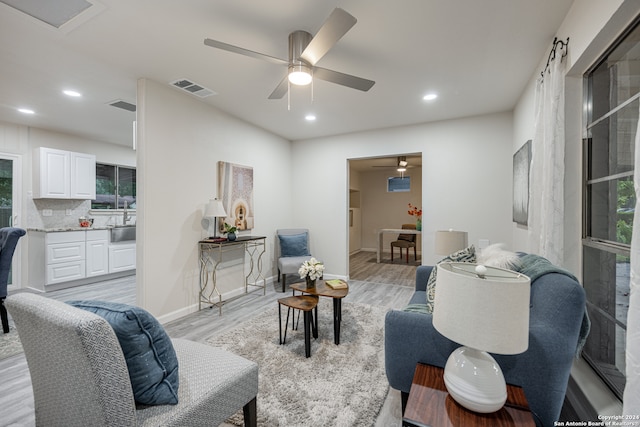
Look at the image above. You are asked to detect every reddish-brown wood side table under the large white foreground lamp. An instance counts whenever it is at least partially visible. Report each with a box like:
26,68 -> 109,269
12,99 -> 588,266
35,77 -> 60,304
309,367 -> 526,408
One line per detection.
402,363 -> 535,427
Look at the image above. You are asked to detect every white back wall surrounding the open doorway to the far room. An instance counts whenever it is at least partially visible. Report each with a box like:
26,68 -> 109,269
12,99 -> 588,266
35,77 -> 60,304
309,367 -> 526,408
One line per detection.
291,113 -> 513,275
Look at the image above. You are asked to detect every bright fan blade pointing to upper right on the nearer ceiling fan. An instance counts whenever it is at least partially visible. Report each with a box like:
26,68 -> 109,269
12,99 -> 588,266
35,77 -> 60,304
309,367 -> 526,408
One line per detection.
300,7 -> 357,65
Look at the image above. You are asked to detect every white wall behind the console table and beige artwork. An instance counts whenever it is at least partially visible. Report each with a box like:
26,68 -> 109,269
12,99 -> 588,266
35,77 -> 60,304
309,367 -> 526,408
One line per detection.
137,79 -> 295,320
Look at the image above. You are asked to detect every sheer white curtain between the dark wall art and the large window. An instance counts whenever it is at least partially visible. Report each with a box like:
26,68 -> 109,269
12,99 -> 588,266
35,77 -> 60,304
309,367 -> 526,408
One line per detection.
528,45 -> 566,266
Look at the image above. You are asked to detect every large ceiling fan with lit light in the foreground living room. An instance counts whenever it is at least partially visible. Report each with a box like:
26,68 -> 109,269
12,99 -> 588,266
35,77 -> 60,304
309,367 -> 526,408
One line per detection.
204,8 -> 375,99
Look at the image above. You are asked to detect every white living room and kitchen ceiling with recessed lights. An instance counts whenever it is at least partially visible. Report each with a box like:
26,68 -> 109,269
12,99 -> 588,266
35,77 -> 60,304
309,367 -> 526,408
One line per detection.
0,0 -> 572,145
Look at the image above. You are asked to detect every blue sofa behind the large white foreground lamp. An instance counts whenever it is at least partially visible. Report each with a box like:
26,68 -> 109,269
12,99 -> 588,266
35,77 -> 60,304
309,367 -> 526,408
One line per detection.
385,266 -> 589,427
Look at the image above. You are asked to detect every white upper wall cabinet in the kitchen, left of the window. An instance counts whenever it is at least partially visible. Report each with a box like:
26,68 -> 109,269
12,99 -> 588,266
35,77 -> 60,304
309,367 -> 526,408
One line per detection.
33,147 -> 96,200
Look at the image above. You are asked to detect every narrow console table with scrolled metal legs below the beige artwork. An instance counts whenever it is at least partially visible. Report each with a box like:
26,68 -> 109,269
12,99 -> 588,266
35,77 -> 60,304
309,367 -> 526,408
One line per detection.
198,236 -> 266,314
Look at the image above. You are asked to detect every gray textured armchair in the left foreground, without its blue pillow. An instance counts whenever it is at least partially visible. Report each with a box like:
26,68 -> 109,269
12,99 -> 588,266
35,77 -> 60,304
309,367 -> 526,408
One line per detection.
7,293 -> 258,427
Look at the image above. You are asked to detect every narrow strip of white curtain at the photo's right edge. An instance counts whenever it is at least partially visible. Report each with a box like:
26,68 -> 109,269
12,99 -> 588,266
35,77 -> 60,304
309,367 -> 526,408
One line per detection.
623,102 -> 640,416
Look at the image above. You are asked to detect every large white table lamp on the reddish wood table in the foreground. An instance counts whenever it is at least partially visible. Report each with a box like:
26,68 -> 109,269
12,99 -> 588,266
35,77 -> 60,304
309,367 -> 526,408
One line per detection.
433,262 -> 530,413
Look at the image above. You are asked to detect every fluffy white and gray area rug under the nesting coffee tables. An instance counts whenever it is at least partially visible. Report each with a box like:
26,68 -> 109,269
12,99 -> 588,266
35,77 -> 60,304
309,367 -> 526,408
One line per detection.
208,298 -> 389,427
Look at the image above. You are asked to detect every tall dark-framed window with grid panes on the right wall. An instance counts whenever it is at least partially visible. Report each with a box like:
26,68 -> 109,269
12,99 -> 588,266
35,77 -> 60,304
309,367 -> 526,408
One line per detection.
583,16 -> 640,399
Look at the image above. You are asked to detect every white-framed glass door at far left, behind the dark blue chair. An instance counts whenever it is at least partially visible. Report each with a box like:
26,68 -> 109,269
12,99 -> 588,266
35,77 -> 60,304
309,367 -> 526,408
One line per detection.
0,153 -> 21,286
